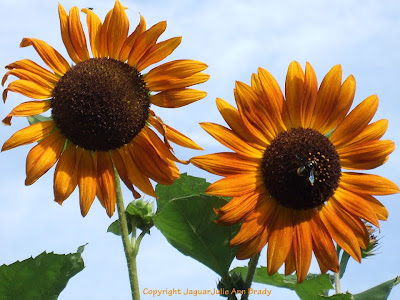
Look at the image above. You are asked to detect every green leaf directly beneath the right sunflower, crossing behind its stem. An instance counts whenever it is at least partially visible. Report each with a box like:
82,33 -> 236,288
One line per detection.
231,267 -> 333,300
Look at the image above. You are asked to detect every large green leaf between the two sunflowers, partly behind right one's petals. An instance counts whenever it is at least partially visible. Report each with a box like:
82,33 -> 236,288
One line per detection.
154,174 -> 239,277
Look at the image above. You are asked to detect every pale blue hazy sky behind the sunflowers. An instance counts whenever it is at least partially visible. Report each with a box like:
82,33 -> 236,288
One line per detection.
0,0 -> 400,300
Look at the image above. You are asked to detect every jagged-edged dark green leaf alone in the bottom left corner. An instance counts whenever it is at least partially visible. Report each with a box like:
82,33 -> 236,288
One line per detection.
0,246 -> 85,300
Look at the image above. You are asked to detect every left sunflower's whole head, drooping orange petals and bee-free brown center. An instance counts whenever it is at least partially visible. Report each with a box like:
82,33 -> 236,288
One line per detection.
2,0 -> 209,217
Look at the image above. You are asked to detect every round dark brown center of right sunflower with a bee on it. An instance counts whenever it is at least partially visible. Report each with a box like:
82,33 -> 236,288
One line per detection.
262,128 -> 341,210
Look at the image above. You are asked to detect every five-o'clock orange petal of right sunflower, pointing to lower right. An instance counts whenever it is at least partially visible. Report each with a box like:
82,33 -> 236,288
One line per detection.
319,202 -> 361,262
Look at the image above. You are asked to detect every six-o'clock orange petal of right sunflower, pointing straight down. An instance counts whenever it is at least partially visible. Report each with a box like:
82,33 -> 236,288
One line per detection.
293,211 -> 313,283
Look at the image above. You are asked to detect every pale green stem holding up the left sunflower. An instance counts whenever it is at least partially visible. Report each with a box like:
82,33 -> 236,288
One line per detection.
114,168 -> 140,300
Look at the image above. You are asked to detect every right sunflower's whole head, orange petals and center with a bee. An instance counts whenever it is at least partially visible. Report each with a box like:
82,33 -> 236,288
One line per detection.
191,62 -> 399,282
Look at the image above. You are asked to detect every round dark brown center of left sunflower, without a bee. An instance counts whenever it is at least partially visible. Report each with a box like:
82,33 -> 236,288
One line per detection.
51,58 -> 150,151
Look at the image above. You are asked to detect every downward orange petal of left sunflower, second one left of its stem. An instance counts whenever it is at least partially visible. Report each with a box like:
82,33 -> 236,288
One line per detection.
76,147 -> 97,217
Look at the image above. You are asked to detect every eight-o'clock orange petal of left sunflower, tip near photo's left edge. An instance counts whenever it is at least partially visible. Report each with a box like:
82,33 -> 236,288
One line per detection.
1,121 -> 55,151
